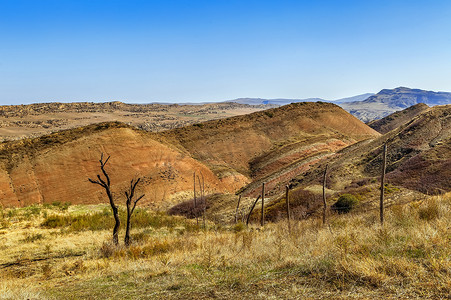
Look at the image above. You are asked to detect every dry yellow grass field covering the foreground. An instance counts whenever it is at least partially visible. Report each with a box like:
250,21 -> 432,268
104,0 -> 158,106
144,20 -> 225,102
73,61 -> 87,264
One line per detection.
0,194 -> 451,299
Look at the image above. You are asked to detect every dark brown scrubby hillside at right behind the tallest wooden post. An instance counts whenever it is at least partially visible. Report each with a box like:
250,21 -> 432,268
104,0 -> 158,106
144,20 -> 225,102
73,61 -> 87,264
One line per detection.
293,105 -> 451,193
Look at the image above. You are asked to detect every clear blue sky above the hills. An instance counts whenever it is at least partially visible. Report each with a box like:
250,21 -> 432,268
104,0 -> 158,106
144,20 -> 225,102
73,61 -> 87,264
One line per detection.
0,0 -> 451,104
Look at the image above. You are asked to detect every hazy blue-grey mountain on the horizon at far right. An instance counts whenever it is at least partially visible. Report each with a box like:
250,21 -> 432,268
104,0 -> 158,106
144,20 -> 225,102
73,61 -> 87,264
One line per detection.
339,87 -> 451,122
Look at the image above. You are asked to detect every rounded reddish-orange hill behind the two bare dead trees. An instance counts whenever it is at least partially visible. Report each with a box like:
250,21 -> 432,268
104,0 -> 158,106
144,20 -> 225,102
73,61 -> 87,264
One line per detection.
0,123 -> 243,206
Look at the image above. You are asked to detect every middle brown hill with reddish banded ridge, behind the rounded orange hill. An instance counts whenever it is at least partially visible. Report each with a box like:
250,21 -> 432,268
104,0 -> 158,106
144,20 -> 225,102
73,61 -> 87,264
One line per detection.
161,102 -> 379,194
